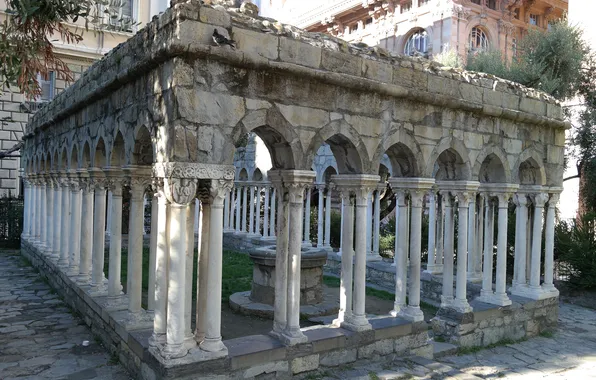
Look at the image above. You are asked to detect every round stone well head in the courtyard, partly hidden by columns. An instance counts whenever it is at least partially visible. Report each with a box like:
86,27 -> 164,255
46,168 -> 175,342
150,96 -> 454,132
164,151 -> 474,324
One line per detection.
250,248 -> 327,305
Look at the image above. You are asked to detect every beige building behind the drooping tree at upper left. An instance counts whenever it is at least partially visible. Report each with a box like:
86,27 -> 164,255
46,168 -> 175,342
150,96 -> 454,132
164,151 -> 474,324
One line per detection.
0,0 -> 170,196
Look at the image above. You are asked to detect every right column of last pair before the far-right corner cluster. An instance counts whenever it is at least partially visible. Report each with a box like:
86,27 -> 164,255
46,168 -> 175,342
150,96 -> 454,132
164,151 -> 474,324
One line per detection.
491,193 -> 511,306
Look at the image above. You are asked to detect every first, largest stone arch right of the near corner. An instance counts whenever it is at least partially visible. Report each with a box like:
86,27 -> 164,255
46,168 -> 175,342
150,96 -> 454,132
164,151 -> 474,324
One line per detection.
231,107 -> 302,169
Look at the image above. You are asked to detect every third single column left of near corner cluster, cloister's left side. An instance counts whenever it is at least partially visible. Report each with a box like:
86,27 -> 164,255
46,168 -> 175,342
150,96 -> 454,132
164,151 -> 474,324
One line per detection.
89,168 -> 106,293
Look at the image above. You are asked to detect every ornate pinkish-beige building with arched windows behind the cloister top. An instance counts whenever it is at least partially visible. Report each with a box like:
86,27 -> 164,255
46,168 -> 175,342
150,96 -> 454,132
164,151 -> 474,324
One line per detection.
262,0 -> 568,58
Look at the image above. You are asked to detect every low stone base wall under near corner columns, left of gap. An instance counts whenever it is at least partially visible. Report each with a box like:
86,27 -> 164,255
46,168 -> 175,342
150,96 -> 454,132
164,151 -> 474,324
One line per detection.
21,241 -> 433,380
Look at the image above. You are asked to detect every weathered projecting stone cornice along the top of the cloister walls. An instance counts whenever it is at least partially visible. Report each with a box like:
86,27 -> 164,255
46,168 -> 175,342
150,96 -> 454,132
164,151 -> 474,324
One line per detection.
27,2 -> 569,137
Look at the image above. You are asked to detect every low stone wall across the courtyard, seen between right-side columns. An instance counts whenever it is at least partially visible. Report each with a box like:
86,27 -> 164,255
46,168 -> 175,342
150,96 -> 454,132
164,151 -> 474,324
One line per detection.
323,253 -> 481,307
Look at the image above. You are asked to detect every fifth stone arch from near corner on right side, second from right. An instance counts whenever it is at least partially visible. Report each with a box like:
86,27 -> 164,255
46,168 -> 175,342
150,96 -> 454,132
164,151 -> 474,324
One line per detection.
472,145 -> 511,183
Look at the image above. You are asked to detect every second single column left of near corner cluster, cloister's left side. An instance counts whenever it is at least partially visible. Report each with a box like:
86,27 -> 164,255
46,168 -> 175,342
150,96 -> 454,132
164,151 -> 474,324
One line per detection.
104,168 -> 124,303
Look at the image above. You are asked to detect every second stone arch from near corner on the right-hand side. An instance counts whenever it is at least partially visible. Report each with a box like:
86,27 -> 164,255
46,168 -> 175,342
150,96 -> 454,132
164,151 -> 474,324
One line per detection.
305,120 -> 368,174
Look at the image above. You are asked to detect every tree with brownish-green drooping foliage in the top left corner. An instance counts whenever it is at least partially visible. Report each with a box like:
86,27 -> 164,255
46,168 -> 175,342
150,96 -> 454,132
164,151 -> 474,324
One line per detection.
0,0 -> 130,98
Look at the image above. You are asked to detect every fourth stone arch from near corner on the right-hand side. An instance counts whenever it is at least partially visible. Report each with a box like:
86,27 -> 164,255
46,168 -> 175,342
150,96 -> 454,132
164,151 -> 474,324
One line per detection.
425,137 -> 472,180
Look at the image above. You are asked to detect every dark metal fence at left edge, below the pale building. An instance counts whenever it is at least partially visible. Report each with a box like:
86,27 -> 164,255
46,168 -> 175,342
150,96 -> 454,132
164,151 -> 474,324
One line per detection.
0,197 -> 24,248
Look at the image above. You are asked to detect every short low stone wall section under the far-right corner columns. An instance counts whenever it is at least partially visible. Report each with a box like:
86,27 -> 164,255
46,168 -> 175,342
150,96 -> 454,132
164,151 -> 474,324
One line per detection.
431,296 -> 559,347
